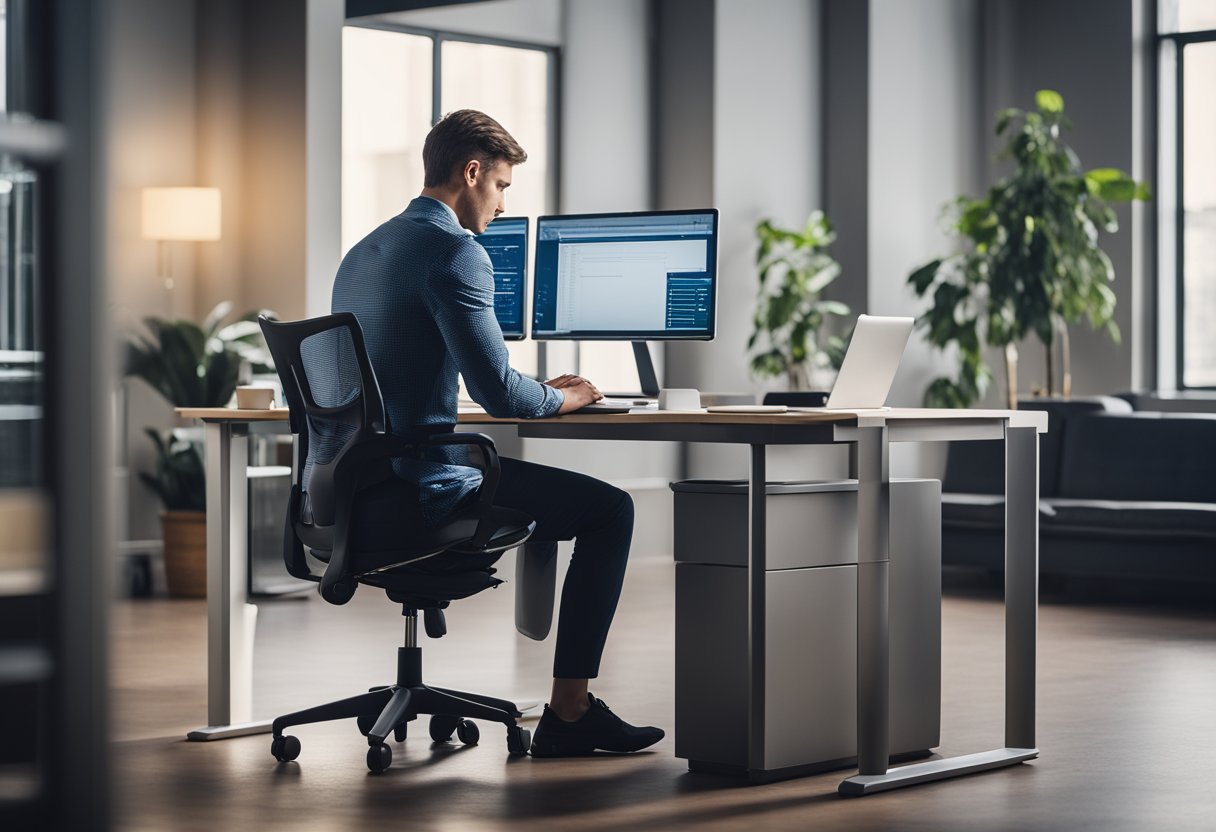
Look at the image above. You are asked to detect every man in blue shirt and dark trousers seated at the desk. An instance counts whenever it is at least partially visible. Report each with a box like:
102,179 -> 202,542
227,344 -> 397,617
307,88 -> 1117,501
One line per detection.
333,109 -> 663,757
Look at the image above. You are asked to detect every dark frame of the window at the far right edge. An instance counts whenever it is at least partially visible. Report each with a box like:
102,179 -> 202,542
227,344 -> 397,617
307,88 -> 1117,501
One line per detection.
1154,29 -> 1216,392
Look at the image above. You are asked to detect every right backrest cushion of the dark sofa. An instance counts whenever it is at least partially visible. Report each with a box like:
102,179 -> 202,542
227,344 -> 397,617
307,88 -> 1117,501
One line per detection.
1058,412 -> 1216,502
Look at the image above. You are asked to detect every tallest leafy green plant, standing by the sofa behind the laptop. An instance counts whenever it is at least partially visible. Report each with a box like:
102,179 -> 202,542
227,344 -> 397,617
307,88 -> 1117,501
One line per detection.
908,90 -> 1149,407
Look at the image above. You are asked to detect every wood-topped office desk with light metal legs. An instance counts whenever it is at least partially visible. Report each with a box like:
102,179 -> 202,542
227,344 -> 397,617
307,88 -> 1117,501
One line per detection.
178,409 -> 1047,796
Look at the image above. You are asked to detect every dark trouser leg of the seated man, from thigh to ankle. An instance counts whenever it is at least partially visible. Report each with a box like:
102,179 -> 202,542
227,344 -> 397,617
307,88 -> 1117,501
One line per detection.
494,457 -> 634,679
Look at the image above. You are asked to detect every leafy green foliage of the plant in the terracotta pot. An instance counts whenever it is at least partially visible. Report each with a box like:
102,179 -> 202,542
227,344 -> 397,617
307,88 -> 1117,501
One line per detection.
126,302 -> 274,511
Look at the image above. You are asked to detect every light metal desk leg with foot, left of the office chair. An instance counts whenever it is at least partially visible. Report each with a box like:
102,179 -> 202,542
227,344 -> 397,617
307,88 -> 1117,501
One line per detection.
186,422 -> 270,741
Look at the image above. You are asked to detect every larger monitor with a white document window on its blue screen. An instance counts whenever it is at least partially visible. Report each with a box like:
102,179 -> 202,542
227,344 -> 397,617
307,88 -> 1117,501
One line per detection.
531,208 -> 717,341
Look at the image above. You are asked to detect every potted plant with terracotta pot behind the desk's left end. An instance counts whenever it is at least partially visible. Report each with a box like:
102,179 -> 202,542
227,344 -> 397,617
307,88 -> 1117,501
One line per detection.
125,302 -> 274,597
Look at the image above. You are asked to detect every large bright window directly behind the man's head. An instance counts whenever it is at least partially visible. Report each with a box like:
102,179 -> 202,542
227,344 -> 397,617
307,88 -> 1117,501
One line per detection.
342,26 -> 557,375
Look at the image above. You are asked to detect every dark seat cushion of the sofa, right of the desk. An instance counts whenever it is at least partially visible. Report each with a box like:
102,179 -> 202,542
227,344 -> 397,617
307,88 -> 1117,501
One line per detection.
1040,497 -> 1216,542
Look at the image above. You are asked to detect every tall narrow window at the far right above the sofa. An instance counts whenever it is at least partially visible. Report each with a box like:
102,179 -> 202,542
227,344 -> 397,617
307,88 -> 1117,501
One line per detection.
1158,0 -> 1216,389
